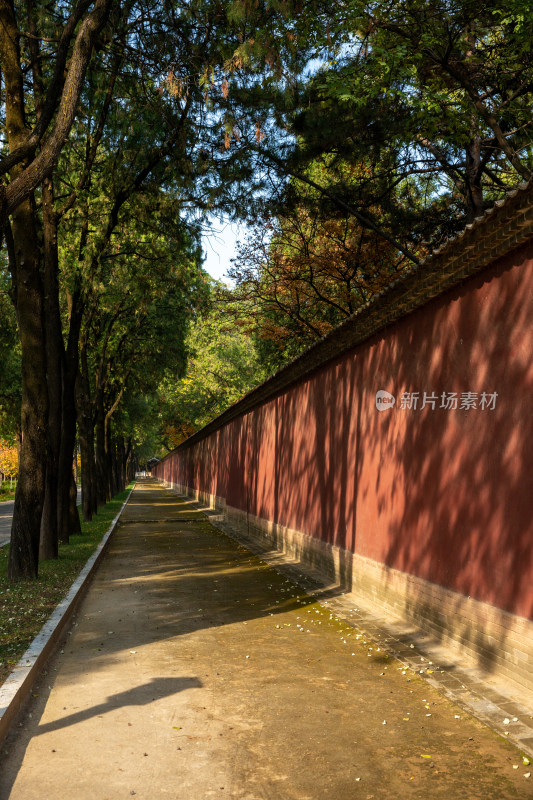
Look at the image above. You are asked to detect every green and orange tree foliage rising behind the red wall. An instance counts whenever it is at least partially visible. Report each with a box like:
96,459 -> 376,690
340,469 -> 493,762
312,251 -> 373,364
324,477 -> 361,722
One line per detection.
212,0 -> 533,368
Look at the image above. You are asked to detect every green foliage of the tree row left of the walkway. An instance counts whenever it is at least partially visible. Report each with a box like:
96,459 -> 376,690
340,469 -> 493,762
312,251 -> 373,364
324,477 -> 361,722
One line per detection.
45,0 -> 256,468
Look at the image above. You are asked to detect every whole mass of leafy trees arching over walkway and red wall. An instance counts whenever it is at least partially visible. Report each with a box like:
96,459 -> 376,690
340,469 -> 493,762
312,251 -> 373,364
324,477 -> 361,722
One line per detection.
0,0 -> 533,579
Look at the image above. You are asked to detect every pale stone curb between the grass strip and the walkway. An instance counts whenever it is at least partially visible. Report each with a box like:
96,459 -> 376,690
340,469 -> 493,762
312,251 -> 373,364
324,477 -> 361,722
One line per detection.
0,484 -> 135,743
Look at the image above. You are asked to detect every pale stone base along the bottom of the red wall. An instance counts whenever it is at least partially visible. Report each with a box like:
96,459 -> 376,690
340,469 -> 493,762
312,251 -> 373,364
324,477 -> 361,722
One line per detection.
166,483 -> 533,693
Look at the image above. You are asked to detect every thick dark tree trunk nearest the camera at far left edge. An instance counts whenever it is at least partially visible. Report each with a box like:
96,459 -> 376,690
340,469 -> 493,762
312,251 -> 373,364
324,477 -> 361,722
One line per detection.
0,2 -> 48,580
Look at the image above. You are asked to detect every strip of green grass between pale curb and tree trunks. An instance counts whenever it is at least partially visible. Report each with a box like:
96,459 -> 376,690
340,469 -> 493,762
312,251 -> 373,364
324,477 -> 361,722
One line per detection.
0,485 -> 131,685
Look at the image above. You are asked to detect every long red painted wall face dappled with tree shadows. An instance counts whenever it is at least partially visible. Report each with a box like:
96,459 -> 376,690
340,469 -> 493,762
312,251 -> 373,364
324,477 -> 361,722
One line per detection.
156,244 -> 533,619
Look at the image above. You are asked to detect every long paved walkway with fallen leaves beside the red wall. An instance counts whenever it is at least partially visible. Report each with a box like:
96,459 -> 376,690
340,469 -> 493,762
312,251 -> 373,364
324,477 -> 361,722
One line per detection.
0,480 -> 533,800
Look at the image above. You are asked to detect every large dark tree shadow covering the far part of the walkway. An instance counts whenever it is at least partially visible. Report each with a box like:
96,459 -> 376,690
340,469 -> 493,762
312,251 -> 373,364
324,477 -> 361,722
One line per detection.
62,484 -> 316,670
